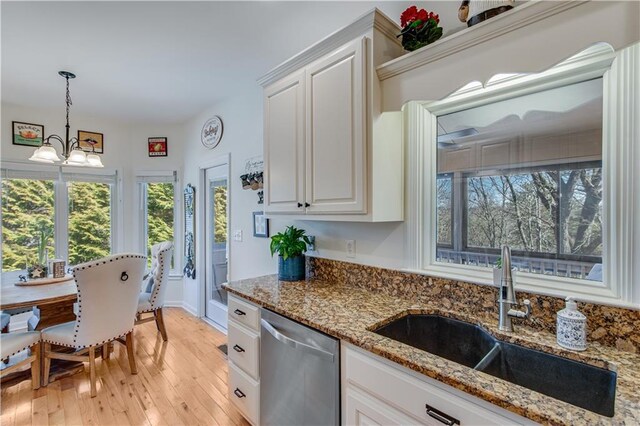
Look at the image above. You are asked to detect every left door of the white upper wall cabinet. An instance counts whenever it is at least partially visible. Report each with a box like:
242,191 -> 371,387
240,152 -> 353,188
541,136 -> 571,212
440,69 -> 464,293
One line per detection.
264,72 -> 305,213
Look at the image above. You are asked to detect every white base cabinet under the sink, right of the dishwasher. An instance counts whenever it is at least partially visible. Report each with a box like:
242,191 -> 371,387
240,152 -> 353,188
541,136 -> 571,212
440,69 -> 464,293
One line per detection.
341,342 -> 535,426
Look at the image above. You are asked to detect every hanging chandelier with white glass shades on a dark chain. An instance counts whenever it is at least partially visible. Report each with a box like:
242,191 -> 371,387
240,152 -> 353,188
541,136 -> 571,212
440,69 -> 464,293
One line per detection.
29,71 -> 104,167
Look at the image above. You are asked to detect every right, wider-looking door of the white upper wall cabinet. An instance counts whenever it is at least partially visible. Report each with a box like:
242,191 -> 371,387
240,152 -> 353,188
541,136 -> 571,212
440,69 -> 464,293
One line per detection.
305,38 -> 367,214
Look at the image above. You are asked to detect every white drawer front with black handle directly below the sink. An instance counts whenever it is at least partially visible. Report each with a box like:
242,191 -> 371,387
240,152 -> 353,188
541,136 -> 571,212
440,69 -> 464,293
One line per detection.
345,348 -> 531,425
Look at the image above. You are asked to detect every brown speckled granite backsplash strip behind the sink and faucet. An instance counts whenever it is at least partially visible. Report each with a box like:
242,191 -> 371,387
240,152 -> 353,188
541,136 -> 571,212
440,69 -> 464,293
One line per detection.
308,257 -> 640,353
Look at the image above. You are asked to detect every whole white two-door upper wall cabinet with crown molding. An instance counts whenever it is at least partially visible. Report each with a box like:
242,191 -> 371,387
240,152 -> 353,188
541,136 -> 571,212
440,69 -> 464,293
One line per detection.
261,10 -> 404,222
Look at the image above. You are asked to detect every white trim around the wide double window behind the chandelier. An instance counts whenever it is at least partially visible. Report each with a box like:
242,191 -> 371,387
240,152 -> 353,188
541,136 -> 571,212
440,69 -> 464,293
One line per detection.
1,161 -> 120,266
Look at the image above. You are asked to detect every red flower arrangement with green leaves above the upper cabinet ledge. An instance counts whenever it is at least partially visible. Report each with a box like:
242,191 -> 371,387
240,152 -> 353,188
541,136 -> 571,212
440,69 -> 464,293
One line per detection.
398,6 -> 442,51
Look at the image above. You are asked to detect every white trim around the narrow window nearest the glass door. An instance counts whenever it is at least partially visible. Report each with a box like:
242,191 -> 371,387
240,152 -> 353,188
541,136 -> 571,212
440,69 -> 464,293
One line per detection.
136,170 -> 183,278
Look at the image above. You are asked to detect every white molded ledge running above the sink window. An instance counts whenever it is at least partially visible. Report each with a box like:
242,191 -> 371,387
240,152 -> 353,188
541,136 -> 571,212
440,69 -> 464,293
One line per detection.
376,0 -> 588,81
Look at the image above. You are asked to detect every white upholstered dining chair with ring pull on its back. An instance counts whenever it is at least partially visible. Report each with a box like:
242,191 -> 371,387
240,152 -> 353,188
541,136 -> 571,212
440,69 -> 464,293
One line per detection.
42,253 -> 147,397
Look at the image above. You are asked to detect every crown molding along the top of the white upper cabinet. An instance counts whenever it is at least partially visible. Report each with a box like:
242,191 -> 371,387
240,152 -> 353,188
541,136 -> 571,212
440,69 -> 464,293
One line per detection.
258,8 -> 400,87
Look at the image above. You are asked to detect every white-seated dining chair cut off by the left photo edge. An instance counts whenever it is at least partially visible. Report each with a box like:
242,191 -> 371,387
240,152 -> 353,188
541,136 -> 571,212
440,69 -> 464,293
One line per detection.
0,331 -> 40,389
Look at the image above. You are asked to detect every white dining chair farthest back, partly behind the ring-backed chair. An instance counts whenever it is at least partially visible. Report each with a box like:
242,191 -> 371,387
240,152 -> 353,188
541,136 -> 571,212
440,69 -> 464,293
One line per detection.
136,241 -> 173,342
